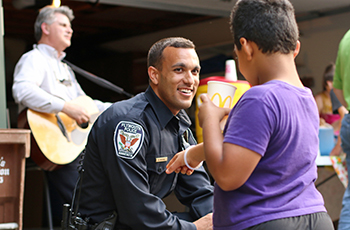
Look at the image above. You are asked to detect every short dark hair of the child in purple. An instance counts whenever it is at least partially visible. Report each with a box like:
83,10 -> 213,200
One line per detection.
230,0 -> 299,54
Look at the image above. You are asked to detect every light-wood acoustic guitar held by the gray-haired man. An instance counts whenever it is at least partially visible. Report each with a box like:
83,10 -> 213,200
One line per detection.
18,96 -> 100,171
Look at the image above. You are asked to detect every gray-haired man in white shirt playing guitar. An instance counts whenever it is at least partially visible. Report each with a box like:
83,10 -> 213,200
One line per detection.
12,6 -> 111,224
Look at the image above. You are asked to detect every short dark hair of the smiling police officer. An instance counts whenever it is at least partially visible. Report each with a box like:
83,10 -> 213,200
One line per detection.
147,37 -> 195,70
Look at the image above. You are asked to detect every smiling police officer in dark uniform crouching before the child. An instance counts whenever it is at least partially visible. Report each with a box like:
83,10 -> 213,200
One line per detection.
79,37 -> 213,230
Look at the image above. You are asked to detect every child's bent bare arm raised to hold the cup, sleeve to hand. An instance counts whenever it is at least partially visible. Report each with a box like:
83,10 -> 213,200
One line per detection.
198,96 -> 261,191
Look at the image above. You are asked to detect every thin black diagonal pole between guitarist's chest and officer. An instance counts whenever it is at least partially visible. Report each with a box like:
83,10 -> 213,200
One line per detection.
62,59 -> 134,97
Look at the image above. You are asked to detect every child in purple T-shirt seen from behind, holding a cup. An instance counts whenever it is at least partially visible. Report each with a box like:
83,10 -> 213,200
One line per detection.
167,0 -> 334,230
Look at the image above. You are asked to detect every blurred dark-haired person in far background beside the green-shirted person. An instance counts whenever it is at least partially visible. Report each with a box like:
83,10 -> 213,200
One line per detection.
315,63 -> 341,132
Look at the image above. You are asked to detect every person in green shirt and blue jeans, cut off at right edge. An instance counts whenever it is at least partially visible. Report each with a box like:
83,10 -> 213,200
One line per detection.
333,27 -> 350,230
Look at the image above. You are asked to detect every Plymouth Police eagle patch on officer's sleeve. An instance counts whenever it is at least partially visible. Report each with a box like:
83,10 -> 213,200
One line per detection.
114,121 -> 145,159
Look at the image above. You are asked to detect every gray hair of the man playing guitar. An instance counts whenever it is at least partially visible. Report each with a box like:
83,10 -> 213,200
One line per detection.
34,6 -> 74,42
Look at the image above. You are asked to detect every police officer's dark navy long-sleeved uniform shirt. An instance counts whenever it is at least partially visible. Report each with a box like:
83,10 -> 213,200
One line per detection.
79,87 -> 213,230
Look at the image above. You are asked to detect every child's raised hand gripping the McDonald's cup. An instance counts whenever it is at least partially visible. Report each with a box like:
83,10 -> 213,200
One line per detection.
198,94 -> 231,128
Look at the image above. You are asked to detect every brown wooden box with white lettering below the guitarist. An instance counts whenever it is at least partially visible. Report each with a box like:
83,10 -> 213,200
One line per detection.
0,129 -> 30,230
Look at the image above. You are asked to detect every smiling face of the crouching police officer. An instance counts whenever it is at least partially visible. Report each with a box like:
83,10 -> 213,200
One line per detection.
151,47 -> 200,114
